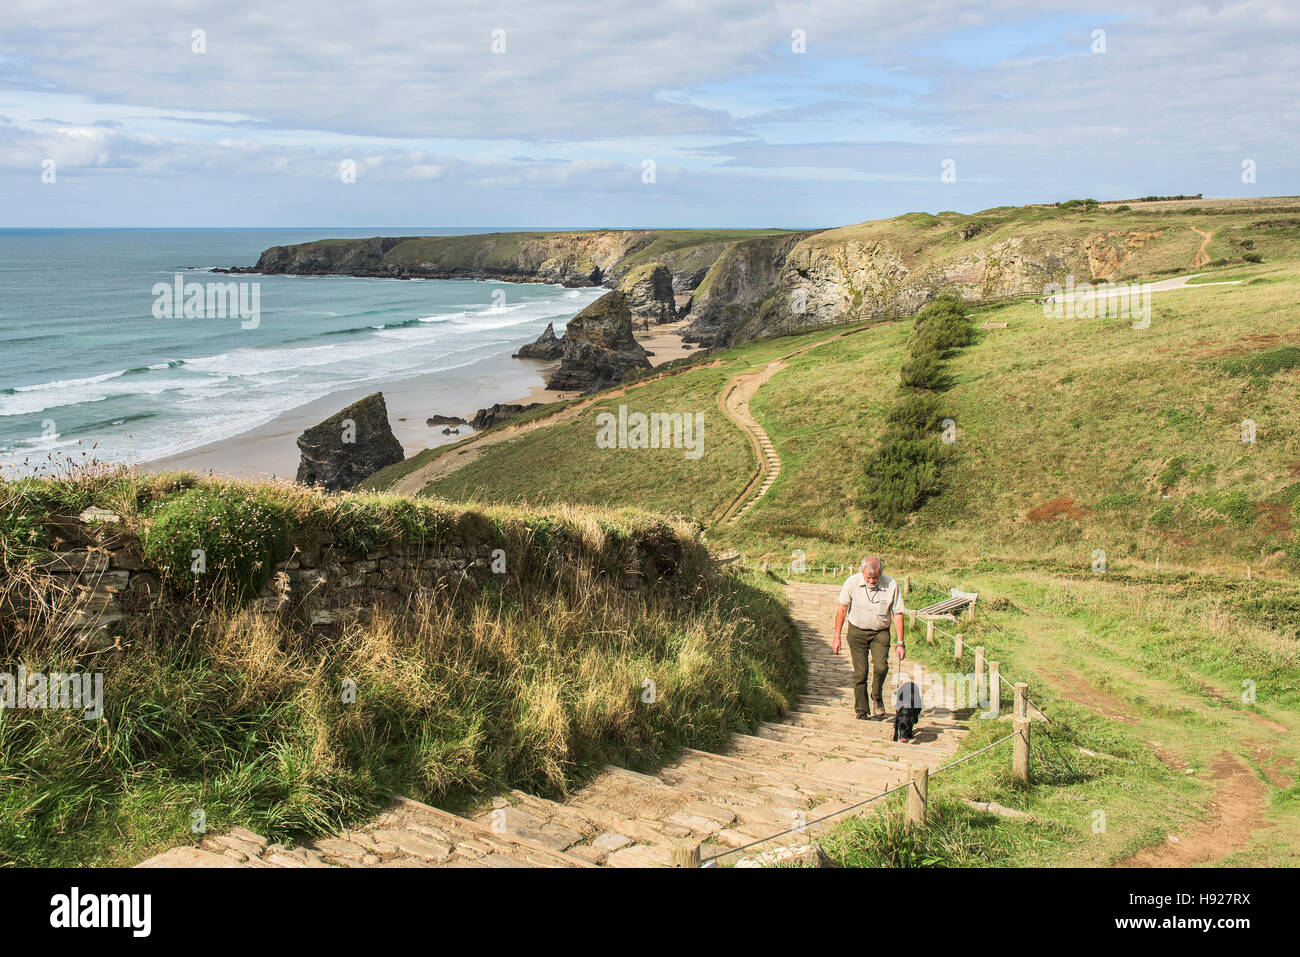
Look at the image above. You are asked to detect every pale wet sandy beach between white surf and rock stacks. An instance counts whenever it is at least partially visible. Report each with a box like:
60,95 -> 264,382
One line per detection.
143,320 -> 693,479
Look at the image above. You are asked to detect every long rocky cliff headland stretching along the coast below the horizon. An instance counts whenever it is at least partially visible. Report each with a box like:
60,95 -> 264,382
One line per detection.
234,200 -> 1244,356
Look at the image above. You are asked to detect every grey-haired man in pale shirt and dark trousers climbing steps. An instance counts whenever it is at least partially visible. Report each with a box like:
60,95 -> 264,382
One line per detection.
831,555 -> 907,720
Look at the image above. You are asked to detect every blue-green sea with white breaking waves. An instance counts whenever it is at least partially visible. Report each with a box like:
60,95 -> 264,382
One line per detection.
0,229 -> 605,476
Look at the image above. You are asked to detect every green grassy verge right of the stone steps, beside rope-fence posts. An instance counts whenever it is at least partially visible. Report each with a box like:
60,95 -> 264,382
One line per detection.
806,568 -> 1300,866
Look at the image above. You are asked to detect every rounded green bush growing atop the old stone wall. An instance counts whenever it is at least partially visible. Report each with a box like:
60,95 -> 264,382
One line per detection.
142,488 -> 290,598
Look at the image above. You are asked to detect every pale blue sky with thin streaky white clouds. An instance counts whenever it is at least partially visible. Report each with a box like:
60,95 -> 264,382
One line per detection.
0,0 -> 1300,229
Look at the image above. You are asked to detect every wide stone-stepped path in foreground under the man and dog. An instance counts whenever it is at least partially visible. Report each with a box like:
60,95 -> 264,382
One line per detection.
139,584 -> 966,867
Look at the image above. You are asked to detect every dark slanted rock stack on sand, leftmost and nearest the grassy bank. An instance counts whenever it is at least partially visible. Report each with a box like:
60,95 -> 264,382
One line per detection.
298,393 -> 404,492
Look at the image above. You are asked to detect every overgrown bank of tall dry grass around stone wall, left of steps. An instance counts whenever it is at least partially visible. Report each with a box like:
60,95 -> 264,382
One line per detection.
0,473 -> 802,866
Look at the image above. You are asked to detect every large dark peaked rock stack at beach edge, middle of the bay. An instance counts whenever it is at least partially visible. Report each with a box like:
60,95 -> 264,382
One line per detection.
546,291 -> 650,394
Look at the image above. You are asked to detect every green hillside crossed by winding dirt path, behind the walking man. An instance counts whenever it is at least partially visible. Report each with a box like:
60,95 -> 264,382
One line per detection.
382,254 -> 1300,572
